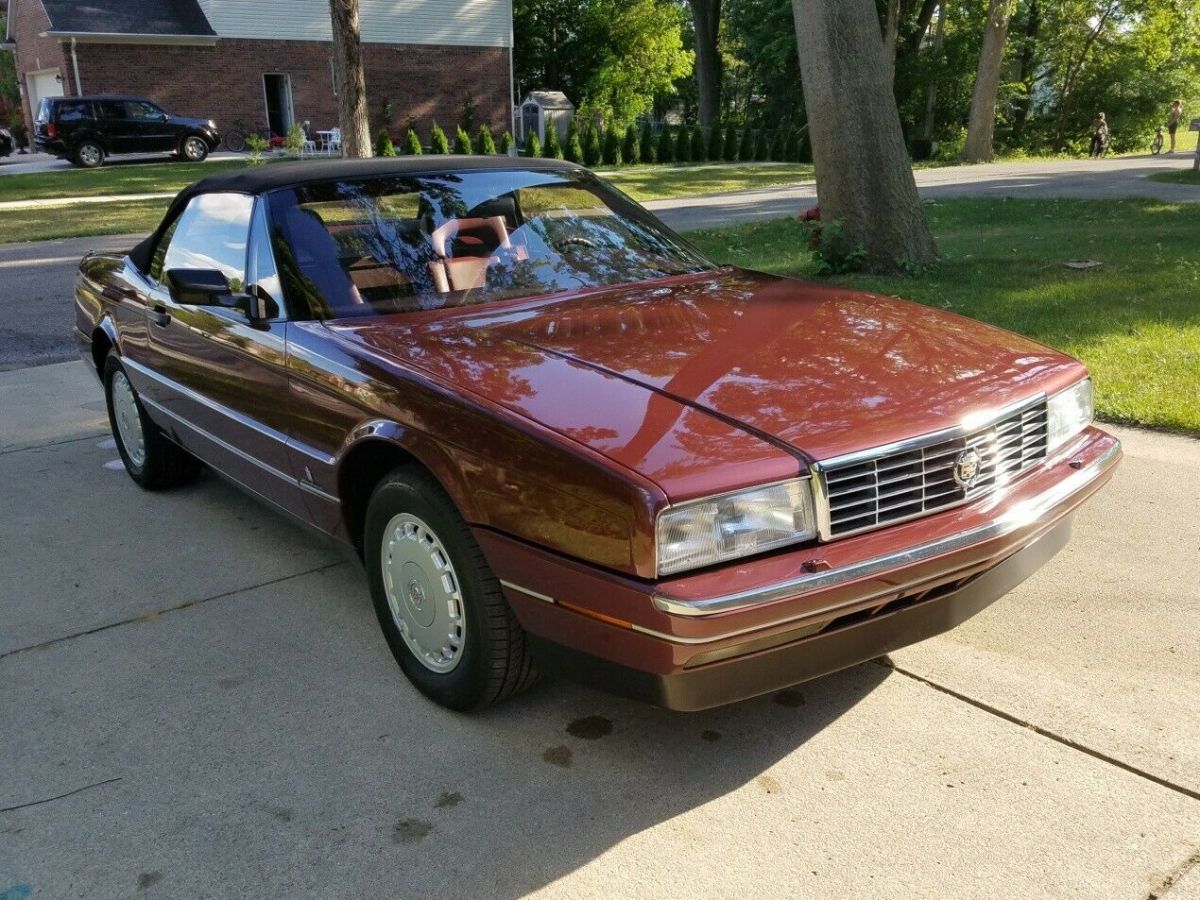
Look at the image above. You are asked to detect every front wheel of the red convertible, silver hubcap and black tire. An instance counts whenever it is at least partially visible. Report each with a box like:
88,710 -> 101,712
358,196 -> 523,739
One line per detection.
364,467 -> 536,710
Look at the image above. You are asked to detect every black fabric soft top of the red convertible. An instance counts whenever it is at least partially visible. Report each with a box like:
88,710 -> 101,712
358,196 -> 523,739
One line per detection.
130,154 -> 581,272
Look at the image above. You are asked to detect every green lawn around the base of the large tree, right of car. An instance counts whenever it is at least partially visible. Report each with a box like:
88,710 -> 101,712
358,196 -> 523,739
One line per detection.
689,199 -> 1200,434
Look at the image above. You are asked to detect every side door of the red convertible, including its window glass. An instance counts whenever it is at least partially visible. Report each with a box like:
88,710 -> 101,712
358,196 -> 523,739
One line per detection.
138,193 -> 306,517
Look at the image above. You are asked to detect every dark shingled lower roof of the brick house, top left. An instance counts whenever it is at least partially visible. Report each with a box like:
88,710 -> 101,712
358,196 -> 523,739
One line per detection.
42,0 -> 216,37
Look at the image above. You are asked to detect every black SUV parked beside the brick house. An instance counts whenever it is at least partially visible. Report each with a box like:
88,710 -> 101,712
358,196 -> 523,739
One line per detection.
34,97 -> 221,169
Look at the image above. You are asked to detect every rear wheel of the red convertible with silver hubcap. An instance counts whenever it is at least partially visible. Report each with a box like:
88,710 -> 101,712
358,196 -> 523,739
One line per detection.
104,350 -> 200,491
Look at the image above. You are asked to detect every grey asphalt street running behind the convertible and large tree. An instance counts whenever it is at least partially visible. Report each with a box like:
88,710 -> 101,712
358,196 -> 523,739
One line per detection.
0,154 -> 1200,371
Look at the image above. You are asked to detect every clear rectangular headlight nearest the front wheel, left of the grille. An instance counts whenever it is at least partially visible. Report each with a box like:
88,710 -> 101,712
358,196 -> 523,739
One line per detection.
655,478 -> 817,575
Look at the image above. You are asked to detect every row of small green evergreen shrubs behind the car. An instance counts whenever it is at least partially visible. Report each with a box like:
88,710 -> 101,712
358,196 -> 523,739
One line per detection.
374,118 -> 812,167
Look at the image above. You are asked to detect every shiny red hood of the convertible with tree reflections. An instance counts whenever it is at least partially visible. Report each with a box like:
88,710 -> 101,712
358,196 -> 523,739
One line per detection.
332,269 -> 1085,501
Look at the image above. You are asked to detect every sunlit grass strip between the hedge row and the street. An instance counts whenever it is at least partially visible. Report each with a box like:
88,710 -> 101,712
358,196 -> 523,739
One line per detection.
600,163 -> 812,200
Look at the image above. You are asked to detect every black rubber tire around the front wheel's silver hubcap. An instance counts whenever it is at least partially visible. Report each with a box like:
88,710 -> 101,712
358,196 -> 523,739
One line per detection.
364,467 -> 538,712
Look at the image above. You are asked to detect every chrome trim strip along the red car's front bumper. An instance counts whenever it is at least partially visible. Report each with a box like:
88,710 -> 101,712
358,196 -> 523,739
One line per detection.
654,442 -> 1121,630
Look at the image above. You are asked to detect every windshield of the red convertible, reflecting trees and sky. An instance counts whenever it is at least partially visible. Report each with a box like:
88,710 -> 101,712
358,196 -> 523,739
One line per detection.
269,169 -> 713,318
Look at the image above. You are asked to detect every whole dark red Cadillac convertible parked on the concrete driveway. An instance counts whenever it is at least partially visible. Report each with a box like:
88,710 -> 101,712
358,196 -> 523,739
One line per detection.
76,157 -> 1121,709
